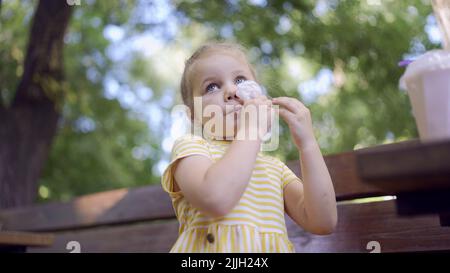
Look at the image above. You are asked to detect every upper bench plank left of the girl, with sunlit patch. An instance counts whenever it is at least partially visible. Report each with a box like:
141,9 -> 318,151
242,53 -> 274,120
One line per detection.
0,185 -> 174,231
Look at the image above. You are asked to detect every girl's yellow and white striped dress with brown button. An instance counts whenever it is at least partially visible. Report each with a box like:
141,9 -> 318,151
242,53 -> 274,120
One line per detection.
161,135 -> 299,252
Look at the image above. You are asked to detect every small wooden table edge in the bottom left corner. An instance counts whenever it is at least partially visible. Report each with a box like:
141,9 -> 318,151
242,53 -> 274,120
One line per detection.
0,231 -> 54,252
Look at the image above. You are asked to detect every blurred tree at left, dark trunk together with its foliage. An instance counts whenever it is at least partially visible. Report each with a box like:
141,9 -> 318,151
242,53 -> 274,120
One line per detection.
0,0 -> 160,204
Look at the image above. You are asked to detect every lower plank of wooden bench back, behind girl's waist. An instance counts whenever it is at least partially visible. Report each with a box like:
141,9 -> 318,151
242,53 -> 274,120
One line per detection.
29,201 -> 450,253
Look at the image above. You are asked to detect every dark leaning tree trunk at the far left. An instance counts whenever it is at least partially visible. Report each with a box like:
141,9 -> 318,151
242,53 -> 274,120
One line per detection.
0,0 -> 72,208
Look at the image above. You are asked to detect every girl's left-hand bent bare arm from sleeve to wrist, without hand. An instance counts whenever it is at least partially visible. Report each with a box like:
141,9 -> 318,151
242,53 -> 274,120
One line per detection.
174,140 -> 261,217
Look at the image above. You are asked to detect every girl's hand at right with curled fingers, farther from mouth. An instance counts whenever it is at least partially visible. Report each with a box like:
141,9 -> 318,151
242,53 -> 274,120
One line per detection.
272,97 -> 317,150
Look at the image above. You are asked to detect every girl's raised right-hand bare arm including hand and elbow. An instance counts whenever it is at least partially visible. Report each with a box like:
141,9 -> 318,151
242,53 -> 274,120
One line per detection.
273,97 -> 337,234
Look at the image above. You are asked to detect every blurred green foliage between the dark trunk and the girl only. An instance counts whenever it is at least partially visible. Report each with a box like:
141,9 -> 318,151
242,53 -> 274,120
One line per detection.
39,1 -> 160,200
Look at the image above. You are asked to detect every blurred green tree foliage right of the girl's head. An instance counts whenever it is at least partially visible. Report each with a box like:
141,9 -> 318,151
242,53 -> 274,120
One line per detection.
176,0 -> 438,159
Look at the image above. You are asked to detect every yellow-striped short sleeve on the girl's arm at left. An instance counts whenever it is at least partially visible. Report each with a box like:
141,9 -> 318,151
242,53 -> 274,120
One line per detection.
161,135 -> 212,197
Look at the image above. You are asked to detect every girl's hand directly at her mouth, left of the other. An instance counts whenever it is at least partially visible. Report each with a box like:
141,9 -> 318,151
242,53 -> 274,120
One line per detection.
237,96 -> 273,140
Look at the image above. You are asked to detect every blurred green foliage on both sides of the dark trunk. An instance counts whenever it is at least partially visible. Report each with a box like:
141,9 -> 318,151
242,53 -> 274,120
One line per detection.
0,1 -> 163,200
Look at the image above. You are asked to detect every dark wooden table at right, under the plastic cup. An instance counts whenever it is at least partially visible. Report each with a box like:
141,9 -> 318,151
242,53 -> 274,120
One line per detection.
356,139 -> 450,226
